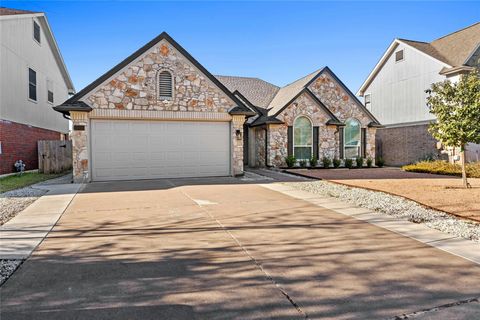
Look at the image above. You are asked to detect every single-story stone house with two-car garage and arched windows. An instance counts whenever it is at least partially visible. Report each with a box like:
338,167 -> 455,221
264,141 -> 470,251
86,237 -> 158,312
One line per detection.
54,33 -> 379,181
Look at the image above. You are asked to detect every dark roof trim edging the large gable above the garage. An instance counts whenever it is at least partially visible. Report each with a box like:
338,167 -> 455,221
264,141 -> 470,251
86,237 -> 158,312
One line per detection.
55,32 -> 253,114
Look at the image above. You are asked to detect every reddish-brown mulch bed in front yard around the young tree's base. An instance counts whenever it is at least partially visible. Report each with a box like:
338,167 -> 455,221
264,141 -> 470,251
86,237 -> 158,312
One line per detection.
287,168 -> 480,222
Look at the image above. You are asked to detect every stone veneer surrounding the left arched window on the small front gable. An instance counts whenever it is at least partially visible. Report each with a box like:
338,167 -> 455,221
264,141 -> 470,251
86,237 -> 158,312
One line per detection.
268,94 -> 338,167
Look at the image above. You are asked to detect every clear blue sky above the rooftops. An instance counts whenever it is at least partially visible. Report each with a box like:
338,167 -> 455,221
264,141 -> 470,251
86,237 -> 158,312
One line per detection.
2,0 -> 480,92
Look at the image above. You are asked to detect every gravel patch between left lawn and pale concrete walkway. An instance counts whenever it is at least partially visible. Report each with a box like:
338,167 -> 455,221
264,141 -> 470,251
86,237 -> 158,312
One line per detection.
0,187 -> 47,225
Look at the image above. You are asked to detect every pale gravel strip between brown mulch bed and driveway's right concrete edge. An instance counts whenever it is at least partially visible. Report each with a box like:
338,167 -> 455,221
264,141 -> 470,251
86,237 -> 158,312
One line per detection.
288,181 -> 480,243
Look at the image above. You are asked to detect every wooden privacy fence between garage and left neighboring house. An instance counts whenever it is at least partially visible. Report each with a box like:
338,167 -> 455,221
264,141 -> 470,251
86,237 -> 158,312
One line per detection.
38,140 -> 72,174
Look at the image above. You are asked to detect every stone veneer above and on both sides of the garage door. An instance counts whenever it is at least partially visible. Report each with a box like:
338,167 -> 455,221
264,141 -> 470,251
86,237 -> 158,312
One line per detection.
71,40 -> 245,182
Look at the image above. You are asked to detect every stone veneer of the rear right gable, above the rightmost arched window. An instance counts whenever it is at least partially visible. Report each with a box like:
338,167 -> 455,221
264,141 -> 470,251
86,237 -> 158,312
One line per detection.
308,72 -> 375,159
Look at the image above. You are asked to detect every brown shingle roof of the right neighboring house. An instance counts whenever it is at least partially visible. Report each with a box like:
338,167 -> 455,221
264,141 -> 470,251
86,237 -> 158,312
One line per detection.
399,22 -> 480,67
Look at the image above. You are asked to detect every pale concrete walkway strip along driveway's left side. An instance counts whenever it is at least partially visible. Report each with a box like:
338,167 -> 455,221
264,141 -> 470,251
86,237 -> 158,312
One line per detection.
0,183 -> 82,259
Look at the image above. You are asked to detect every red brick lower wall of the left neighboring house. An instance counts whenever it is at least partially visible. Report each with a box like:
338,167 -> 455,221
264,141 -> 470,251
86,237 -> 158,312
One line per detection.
0,120 -> 61,174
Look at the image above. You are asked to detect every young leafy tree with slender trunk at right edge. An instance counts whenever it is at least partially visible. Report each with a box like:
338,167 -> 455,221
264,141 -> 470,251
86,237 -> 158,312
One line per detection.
427,72 -> 480,188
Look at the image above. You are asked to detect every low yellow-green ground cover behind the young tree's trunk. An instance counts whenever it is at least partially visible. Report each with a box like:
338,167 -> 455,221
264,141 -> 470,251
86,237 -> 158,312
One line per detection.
402,160 -> 480,178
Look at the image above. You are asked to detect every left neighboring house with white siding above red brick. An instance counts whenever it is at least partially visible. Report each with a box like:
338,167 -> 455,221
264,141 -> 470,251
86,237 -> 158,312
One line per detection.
0,8 -> 74,174
